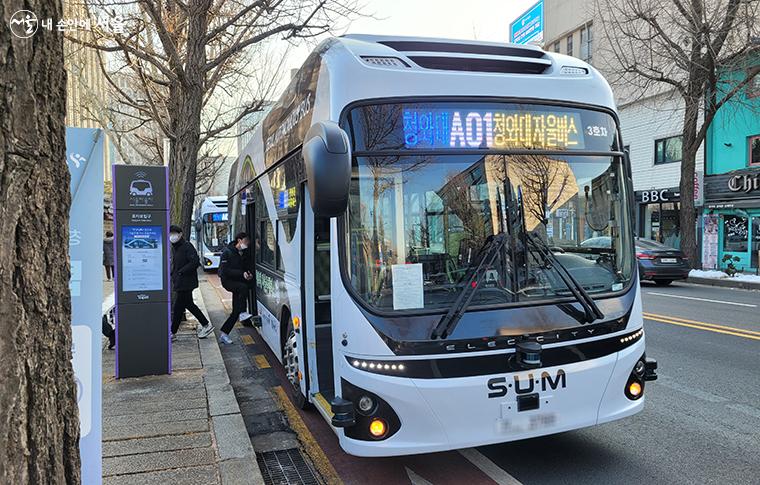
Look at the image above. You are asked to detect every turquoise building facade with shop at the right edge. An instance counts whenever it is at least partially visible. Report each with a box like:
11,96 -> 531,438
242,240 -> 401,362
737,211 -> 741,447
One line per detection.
702,62 -> 760,272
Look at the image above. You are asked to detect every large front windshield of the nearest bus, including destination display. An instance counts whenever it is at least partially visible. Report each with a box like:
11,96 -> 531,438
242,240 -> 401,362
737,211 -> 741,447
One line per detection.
345,103 -> 633,311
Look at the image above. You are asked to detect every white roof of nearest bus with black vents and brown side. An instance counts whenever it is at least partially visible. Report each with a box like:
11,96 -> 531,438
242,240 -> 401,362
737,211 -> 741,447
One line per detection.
228,34 -> 615,196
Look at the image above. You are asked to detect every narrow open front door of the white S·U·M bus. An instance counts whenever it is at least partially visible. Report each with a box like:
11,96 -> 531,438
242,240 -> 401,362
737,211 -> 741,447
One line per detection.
302,188 -> 335,402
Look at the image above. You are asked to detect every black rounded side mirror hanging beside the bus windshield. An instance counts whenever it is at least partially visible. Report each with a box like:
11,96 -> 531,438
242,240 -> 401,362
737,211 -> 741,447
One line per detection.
302,121 -> 351,217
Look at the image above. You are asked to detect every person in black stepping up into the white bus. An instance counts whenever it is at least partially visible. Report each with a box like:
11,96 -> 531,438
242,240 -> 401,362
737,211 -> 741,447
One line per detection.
219,232 -> 253,344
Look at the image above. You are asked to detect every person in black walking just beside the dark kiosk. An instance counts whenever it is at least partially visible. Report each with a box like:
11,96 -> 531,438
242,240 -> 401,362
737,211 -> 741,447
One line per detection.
169,226 -> 214,341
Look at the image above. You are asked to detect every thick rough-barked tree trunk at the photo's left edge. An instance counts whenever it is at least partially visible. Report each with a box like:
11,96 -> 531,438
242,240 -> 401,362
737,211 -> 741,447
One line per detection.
0,0 -> 81,484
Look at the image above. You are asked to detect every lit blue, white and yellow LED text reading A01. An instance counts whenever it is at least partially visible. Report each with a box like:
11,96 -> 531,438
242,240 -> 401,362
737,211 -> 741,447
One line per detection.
403,109 -> 584,149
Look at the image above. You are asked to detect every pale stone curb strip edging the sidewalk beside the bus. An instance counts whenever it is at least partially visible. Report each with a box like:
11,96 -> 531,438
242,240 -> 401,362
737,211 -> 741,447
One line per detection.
194,282 -> 264,485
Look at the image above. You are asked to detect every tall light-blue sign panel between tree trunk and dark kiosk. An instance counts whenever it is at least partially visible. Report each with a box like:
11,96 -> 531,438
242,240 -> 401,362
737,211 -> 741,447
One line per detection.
66,128 -> 104,484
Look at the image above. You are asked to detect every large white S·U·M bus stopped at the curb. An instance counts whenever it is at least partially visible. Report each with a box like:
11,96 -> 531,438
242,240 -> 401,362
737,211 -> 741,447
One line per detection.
229,35 -> 656,456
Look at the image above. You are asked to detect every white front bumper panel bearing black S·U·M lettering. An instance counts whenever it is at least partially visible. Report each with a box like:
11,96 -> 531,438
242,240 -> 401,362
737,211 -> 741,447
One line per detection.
337,338 -> 651,456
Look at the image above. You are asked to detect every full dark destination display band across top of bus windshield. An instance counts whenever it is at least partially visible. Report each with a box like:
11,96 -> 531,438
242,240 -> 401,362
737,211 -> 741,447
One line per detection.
344,101 -> 620,152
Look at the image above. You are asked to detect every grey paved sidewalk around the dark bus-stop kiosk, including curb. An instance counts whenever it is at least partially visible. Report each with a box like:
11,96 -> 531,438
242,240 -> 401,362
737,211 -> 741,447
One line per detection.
103,282 -> 264,485
